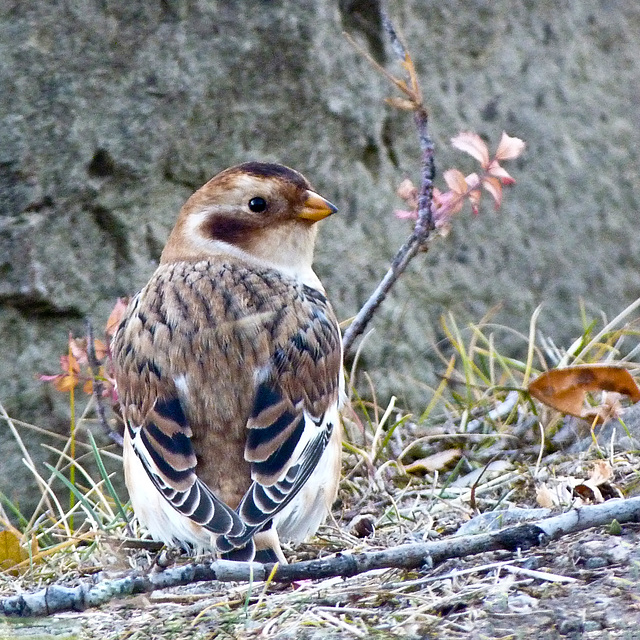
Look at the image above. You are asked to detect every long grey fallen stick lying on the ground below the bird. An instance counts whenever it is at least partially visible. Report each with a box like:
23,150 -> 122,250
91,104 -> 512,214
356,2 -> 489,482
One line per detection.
5,497 -> 640,616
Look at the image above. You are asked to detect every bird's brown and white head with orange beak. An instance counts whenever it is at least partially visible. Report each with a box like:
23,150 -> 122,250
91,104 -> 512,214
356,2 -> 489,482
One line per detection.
161,162 -> 337,273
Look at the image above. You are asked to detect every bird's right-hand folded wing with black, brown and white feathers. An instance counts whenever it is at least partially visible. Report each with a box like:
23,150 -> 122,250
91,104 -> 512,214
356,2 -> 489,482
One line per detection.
217,288 -> 342,551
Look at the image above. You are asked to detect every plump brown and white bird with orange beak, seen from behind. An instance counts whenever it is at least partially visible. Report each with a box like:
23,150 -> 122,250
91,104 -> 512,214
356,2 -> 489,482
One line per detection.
111,162 -> 345,563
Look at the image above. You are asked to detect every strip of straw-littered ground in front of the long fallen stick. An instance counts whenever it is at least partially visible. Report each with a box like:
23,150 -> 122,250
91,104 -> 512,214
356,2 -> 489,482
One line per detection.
0,525 -> 640,640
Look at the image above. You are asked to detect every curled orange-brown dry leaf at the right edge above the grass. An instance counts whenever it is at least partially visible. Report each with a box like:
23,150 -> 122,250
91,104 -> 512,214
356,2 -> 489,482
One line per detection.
529,365 -> 640,422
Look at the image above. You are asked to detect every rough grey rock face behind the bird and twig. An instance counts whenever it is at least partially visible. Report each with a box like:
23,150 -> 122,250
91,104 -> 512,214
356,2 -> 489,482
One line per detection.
0,0 -> 640,508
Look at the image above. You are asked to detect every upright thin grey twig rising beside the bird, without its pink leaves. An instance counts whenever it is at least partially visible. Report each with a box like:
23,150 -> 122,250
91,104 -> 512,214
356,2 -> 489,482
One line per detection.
342,12 -> 435,352
